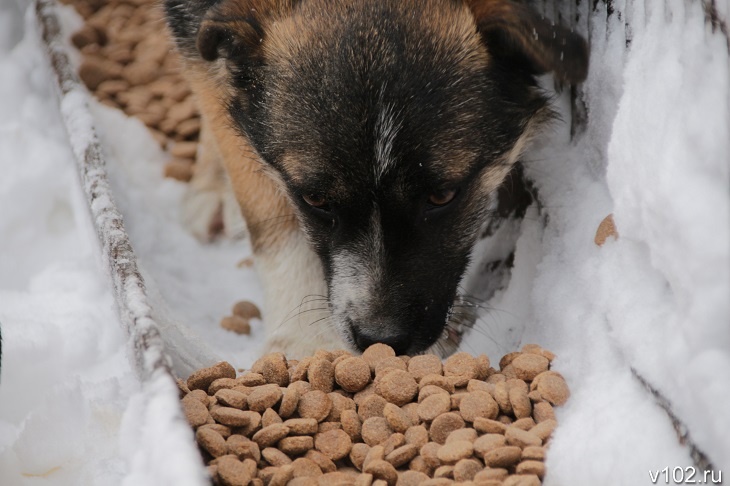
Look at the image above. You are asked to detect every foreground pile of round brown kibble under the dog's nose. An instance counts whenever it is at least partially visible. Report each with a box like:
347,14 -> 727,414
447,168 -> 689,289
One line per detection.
178,344 -> 569,486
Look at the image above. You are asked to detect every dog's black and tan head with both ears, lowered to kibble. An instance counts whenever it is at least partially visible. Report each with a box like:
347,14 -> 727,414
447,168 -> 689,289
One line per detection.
181,0 -> 587,353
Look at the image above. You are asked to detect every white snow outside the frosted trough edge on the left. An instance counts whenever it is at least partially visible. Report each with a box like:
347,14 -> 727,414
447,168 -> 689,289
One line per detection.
0,3 -> 205,486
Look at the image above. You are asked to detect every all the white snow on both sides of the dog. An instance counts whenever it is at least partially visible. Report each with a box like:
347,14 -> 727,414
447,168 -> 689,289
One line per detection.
0,0 -> 730,486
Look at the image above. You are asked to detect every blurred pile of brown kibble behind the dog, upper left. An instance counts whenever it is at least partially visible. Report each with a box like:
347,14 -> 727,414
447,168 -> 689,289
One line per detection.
64,0 -> 200,181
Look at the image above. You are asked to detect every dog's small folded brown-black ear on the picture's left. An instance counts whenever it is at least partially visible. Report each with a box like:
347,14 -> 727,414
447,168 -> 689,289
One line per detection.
196,0 -> 296,61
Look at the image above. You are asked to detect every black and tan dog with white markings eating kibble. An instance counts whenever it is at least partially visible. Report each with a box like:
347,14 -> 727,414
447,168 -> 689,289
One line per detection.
165,0 -> 588,356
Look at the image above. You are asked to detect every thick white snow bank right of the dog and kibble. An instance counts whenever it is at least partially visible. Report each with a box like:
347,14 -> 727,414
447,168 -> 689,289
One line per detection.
460,0 -> 730,485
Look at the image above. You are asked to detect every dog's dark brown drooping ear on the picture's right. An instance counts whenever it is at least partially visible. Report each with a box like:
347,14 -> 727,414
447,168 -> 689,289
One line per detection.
466,0 -> 588,83
